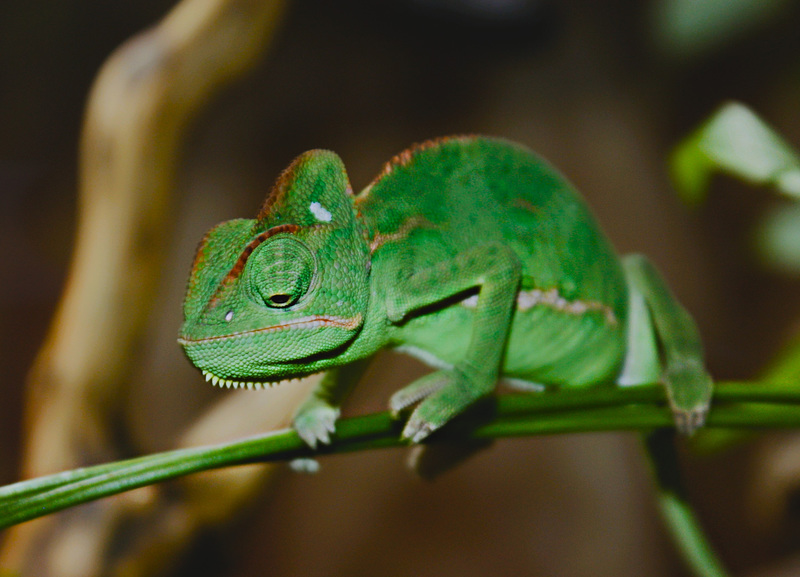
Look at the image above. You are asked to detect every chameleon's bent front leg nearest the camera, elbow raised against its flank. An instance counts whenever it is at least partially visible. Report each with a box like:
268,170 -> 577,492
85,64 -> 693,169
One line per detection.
387,244 -> 521,442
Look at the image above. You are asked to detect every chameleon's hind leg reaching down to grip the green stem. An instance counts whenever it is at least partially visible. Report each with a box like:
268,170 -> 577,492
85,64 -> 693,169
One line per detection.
621,254 -> 713,434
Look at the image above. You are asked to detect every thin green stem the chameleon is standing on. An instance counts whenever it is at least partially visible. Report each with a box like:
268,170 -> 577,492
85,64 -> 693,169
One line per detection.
0,383 -> 800,528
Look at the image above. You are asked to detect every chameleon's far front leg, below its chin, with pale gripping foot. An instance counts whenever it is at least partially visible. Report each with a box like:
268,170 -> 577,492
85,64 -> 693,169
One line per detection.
292,357 -> 371,449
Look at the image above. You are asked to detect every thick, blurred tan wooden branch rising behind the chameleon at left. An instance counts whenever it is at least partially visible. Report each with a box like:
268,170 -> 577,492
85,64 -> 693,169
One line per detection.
0,0 -> 291,577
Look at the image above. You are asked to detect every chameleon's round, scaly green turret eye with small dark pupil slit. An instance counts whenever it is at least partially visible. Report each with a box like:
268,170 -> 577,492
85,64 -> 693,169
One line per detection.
247,237 -> 315,309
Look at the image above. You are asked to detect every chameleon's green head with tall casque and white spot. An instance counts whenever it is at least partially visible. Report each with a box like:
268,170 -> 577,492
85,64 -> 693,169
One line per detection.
179,150 -> 369,386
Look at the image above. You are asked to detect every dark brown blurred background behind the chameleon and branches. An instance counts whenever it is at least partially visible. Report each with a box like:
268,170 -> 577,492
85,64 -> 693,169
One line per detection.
0,0 -> 800,576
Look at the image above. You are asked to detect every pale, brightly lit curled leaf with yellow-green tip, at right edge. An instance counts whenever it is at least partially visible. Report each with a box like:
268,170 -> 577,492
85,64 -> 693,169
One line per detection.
671,102 -> 800,204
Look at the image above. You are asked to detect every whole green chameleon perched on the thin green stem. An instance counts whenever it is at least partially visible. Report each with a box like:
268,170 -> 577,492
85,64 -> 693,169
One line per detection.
179,137 -> 712,447
